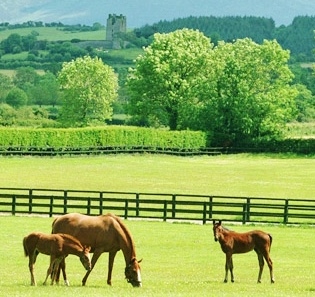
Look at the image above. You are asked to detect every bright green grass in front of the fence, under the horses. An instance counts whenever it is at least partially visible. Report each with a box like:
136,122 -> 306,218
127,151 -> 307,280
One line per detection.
0,217 -> 315,297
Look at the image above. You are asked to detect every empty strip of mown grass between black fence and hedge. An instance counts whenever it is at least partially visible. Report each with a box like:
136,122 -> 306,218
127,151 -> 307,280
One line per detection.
0,154 -> 315,199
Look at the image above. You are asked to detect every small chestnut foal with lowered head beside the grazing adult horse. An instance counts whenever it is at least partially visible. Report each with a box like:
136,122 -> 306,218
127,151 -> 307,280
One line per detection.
23,232 -> 91,286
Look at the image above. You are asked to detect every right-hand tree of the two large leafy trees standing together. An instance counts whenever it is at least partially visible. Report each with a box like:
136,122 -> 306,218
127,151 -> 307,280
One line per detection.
204,38 -> 297,141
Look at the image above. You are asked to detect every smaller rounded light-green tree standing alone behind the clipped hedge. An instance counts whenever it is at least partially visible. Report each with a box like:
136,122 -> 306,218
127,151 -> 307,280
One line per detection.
58,56 -> 118,126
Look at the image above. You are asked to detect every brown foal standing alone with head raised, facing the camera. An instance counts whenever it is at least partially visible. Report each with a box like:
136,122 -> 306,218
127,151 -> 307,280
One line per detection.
213,221 -> 275,283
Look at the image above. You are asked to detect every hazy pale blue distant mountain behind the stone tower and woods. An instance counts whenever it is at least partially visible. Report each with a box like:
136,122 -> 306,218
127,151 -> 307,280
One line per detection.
0,0 -> 315,28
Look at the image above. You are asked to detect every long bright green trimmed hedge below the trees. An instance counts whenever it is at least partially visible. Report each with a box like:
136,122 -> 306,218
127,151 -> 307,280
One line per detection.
0,126 -> 207,150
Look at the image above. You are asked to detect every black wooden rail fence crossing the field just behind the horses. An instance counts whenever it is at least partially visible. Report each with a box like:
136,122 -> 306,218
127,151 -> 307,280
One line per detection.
0,188 -> 315,224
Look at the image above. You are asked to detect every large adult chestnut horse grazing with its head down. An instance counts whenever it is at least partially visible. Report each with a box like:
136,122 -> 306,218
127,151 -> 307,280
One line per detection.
52,213 -> 142,287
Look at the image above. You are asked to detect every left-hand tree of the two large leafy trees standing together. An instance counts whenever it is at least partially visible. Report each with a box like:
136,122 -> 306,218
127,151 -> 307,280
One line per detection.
127,29 -> 215,130
